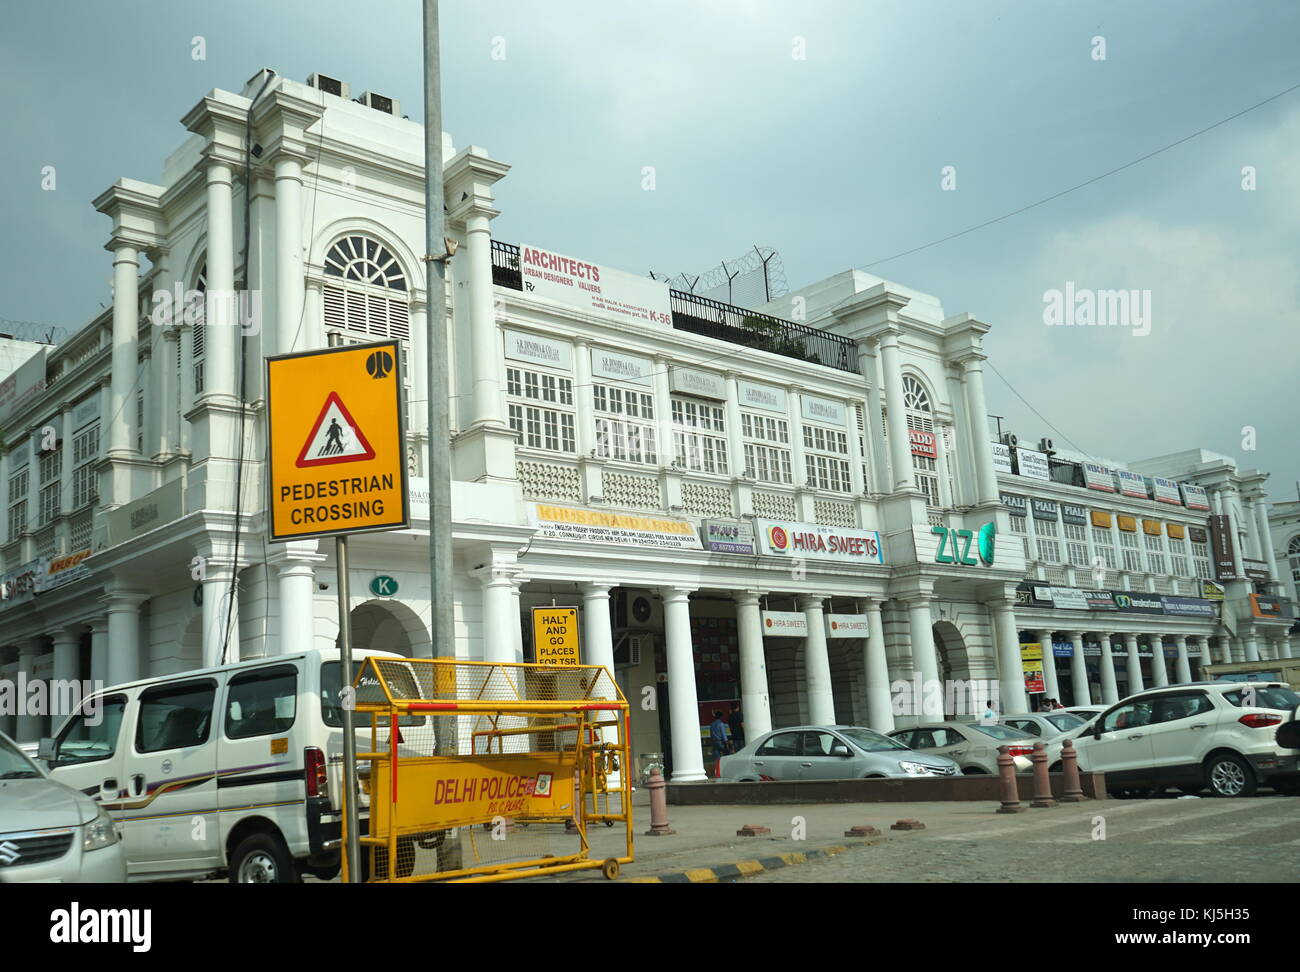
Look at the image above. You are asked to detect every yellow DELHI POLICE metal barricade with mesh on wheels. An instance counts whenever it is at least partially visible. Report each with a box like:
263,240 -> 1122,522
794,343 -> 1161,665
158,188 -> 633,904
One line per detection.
343,658 -> 633,882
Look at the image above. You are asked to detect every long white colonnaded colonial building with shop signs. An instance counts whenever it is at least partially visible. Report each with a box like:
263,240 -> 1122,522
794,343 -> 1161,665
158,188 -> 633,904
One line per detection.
0,71 -> 1290,781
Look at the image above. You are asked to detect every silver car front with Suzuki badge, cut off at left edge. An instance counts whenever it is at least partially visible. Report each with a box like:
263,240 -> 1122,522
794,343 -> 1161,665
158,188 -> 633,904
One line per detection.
0,733 -> 126,884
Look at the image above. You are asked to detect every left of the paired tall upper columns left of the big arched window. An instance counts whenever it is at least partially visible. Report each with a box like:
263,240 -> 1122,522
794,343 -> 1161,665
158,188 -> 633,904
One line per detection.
202,161 -> 239,400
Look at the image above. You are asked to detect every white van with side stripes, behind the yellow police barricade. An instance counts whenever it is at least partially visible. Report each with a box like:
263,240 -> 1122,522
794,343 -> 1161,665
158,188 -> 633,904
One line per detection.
42,650 -> 424,884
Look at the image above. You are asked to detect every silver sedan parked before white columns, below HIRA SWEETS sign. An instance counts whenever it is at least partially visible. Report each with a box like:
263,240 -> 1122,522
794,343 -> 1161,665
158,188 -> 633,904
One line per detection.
718,725 -> 958,782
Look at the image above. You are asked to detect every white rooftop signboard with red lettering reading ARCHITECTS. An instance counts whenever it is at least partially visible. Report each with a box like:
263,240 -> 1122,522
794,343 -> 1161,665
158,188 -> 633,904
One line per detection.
519,243 -> 672,327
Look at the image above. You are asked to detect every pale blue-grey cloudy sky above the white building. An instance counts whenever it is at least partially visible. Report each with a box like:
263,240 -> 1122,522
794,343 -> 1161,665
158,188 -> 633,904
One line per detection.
0,0 -> 1300,499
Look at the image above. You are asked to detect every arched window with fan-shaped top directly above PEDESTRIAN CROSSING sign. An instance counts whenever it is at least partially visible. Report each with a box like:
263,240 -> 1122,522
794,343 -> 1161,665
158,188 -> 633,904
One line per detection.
325,235 -> 411,386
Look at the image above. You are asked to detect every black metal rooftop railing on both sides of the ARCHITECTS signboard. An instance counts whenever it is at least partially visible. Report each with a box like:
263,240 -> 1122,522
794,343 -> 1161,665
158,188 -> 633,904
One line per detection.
491,239 -> 858,372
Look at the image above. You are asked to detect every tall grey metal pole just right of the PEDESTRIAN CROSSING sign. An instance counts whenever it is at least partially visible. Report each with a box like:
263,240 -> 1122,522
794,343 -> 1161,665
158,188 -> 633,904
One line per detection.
424,0 -> 460,871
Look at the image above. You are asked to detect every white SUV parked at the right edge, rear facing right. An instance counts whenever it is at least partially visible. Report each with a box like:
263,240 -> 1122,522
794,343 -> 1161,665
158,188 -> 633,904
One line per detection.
1074,682 -> 1300,797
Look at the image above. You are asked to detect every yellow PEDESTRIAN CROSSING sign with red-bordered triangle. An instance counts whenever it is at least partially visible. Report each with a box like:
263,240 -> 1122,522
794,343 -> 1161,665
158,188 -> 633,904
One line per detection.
267,340 -> 411,541
